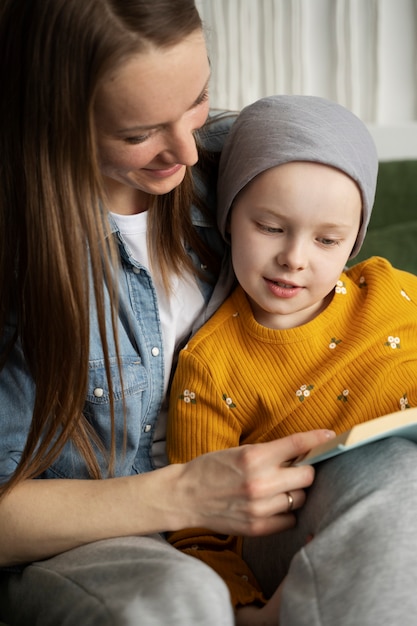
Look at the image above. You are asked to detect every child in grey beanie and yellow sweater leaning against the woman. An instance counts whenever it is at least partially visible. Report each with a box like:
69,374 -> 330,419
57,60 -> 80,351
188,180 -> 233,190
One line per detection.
168,96 -> 417,616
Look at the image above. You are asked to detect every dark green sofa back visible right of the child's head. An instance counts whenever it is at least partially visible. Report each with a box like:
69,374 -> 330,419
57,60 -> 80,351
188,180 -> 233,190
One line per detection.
349,160 -> 417,274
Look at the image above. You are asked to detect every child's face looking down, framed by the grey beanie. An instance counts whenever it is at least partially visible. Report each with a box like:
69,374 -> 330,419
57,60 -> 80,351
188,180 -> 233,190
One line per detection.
230,162 -> 362,329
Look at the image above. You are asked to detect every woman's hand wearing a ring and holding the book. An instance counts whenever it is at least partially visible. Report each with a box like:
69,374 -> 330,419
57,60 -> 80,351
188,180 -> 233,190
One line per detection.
171,430 -> 334,536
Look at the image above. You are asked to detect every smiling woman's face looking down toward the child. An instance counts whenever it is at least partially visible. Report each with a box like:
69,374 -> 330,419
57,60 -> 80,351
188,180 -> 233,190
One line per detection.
95,31 -> 210,214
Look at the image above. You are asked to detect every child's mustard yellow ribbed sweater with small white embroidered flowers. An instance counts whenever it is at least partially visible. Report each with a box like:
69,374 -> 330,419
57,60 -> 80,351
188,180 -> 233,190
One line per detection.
167,257 -> 417,605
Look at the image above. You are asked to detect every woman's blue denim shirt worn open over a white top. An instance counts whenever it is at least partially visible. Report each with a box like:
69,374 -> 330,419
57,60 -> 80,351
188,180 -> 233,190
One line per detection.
0,112 -> 233,482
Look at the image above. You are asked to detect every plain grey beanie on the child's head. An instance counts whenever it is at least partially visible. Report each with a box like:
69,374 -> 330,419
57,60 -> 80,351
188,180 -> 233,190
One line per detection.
218,96 -> 378,258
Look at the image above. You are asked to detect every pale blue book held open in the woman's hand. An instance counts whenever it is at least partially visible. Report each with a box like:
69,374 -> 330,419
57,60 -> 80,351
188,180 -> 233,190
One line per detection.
293,407 -> 417,465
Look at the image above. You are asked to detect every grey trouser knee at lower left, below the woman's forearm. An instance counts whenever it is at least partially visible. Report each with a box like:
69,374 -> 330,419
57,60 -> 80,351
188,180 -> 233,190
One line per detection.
0,535 -> 234,626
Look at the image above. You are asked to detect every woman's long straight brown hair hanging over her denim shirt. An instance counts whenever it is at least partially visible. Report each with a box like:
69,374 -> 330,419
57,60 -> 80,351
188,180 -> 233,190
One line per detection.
0,0 -> 214,490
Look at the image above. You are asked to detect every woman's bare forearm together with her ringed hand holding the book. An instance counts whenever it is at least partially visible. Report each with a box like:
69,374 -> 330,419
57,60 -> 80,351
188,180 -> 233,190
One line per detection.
0,431 -> 331,566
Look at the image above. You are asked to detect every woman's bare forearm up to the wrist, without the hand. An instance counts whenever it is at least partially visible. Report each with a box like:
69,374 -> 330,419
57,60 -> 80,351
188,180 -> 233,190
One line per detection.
0,466 -> 175,566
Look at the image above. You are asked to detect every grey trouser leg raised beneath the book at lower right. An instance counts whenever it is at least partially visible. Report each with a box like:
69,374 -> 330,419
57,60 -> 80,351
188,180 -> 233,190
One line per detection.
244,438 -> 417,626
